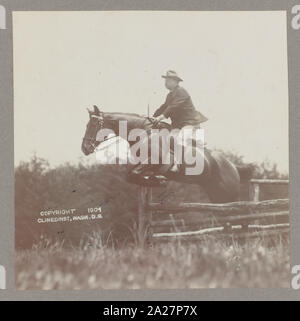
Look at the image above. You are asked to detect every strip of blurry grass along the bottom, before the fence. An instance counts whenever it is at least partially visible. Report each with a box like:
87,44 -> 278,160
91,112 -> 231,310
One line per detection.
15,234 -> 290,290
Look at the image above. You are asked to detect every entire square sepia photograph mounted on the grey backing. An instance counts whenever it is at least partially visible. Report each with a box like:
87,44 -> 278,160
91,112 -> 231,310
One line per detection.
12,10 -> 290,290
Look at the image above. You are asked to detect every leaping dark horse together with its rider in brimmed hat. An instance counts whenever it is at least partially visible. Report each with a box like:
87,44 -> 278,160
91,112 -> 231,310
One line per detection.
81,71 -> 252,203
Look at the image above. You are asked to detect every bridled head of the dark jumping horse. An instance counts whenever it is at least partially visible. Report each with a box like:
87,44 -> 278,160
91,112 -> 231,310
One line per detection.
81,106 -> 104,155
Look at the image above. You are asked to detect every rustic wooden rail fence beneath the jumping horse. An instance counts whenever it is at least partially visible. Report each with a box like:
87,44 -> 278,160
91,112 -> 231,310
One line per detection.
138,179 -> 289,245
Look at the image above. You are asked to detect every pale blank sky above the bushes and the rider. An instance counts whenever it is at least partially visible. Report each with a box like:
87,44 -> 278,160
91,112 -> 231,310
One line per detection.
13,11 -> 288,172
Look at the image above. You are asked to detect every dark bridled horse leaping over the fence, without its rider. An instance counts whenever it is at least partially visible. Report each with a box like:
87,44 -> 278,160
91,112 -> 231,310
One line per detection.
81,106 -> 251,203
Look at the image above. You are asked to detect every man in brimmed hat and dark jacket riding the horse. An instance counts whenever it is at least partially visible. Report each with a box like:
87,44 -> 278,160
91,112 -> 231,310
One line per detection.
133,70 -> 207,183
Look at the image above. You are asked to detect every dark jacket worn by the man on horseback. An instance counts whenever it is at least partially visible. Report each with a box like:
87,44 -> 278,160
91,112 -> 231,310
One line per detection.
153,86 -> 207,128
